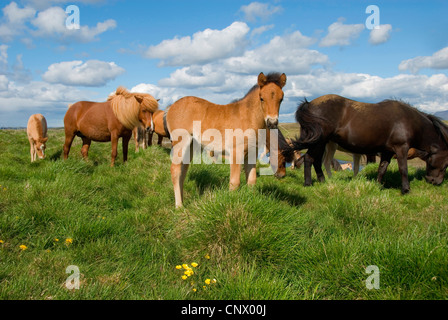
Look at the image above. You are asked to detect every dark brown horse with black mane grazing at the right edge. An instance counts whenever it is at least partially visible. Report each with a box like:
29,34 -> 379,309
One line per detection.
284,95 -> 448,194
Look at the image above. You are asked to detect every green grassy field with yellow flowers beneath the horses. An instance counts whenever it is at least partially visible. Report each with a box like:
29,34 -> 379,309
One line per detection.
0,126 -> 448,300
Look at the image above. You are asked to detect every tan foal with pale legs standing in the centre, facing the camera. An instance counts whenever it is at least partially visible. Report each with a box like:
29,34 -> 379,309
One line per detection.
164,73 -> 286,207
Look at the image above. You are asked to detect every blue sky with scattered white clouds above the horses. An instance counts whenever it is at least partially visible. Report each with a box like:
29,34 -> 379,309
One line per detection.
0,0 -> 448,127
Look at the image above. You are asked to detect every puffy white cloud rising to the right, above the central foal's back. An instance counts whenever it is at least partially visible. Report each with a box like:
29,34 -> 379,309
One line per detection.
145,22 -> 249,66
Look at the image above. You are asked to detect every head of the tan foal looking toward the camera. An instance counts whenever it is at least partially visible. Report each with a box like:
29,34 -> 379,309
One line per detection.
258,72 -> 286,129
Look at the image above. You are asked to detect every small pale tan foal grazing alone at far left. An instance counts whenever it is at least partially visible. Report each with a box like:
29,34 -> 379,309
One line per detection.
26,113 -> 48,162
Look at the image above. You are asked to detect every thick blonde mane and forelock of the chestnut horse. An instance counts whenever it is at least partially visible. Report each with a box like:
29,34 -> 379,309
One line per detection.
107,86 -> 159,130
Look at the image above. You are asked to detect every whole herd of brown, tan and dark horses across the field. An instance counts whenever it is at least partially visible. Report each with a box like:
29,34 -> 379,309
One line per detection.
27,73 -> 448,207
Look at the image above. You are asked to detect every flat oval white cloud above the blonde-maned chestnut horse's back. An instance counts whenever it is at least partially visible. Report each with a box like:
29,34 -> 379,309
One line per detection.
42,60 -> 125,87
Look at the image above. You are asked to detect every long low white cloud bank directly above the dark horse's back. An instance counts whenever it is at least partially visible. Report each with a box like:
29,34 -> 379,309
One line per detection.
284,69 -> 448,112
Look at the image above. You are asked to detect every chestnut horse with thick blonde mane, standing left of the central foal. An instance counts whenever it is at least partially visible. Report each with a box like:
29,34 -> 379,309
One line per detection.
64,87 -> 158,166
